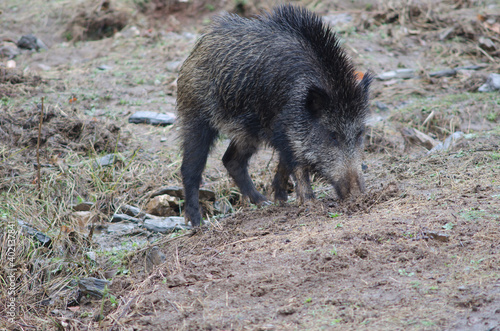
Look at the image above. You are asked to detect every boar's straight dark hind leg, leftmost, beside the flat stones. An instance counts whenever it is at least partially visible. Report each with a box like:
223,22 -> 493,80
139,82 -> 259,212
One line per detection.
181,122 -> 217,226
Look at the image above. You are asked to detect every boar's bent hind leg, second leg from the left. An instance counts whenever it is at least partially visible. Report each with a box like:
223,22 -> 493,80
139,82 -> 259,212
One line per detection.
222,140 -> 267,204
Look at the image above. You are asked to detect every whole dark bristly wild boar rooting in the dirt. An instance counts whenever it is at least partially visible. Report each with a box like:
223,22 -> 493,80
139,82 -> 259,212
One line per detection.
177,5 -> 371,226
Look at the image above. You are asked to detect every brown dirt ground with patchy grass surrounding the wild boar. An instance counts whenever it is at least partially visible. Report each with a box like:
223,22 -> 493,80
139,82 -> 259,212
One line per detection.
0,0 -> 500,331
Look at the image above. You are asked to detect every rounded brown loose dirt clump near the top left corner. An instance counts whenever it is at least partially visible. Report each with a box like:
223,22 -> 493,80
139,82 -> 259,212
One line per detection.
64,0 -> 129,41
